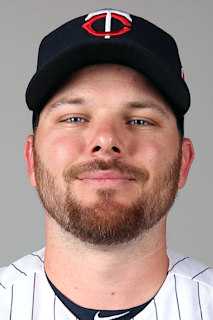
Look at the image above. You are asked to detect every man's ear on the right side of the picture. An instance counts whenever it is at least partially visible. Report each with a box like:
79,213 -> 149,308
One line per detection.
178,138 -> 194,189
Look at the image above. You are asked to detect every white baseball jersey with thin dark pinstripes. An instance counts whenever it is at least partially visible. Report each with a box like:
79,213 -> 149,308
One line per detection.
0,249 -> 213,320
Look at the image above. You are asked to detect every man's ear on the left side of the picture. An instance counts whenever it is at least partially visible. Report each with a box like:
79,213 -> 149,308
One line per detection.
24,135 -> 36,187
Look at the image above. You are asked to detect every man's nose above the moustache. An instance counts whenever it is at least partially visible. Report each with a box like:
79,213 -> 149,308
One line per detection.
90,121 -> 124,156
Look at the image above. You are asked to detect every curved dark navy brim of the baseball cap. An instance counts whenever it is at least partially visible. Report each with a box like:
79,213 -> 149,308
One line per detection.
26,40 -> 190,114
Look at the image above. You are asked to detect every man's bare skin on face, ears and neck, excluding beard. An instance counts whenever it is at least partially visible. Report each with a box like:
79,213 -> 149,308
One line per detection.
25,65 -> 194,310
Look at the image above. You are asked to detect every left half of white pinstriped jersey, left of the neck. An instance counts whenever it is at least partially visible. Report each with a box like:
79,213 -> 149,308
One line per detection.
0,249 -> 58,320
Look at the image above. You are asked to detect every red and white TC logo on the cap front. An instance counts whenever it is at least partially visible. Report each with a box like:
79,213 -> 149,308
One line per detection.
82,9 -> 132,39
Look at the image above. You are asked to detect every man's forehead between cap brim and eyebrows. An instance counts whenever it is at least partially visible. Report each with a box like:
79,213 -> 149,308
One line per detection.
41,64 -> 171,116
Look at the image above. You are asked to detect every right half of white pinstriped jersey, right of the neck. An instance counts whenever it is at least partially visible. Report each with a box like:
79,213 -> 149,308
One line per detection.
144,250 -> 213,320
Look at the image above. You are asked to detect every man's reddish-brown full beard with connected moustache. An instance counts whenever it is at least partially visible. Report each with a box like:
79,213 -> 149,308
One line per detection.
34,147 -> 181,246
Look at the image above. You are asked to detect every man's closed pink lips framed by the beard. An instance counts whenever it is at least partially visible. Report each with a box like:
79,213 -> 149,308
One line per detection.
78,171 -> 135,188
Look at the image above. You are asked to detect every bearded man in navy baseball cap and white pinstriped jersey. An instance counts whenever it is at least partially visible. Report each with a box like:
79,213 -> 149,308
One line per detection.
0,10 -> 213,320
